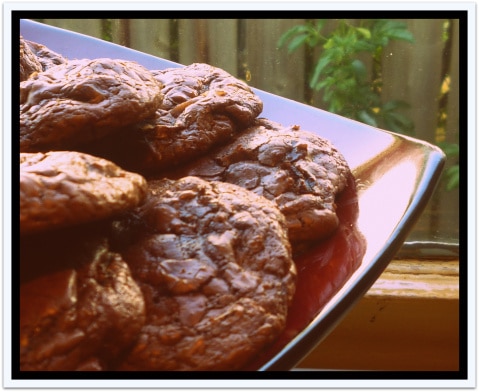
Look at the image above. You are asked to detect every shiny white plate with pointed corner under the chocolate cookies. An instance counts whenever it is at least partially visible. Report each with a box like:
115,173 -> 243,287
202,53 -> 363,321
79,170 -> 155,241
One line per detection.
21,20 -> 445,370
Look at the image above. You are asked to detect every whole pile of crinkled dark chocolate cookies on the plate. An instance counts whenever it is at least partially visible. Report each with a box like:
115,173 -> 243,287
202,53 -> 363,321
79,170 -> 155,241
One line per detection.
19,38 -> 351,370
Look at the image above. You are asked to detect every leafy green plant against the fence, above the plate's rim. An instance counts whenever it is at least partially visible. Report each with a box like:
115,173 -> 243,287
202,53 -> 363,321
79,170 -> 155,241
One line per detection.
278,19 -> 414,134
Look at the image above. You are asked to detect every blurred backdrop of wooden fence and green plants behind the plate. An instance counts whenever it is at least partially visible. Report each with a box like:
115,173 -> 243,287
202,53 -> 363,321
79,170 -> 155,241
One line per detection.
31,19 -> 459,254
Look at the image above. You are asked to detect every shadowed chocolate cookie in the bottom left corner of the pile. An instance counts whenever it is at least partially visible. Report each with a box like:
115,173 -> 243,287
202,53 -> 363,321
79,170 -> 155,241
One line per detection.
20,237 -> 145,371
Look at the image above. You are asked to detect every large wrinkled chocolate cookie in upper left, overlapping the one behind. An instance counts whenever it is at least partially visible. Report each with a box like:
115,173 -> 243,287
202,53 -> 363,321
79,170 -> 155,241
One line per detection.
20,59 -> 161,152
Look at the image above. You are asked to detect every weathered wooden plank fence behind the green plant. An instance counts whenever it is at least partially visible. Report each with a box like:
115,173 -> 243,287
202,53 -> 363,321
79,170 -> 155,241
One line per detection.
30,19 -> 460,243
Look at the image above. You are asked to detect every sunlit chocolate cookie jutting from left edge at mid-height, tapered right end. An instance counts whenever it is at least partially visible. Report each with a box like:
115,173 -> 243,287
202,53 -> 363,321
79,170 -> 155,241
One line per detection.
20,151 -> 147,233
